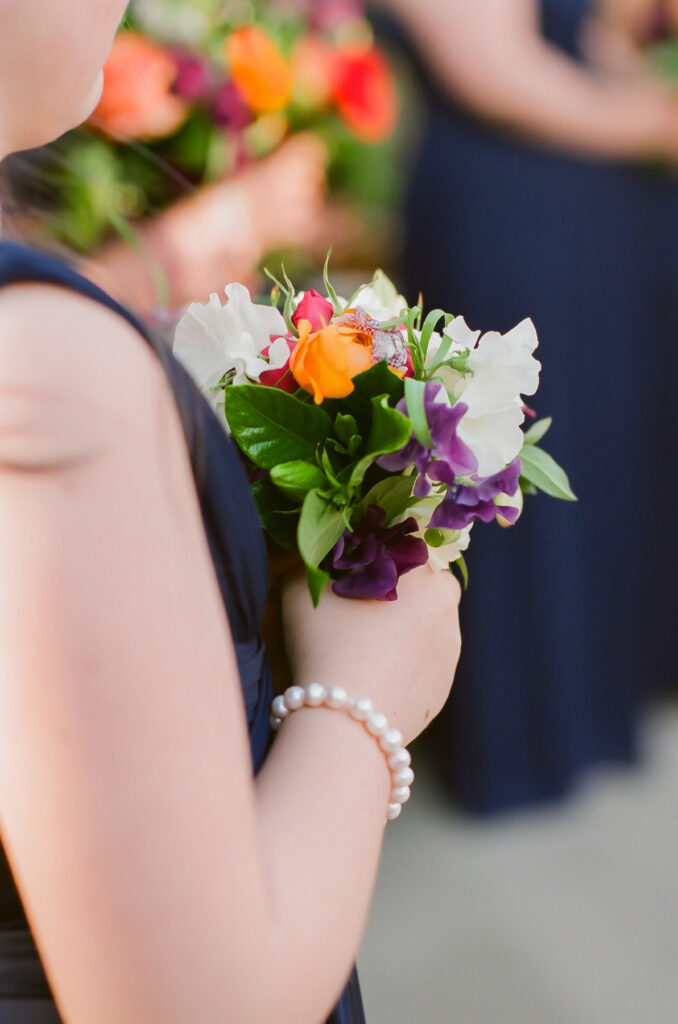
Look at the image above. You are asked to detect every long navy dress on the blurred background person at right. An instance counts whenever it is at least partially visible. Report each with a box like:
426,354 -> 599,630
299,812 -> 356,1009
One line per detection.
405,0 -> 678,813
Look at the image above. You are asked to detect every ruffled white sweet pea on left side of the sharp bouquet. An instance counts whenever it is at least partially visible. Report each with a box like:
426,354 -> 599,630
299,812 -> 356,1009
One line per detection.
173,284 -> 289,395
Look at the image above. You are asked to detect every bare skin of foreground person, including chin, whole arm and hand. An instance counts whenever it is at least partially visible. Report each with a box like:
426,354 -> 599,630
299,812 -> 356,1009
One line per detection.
0,0 -> 460,1024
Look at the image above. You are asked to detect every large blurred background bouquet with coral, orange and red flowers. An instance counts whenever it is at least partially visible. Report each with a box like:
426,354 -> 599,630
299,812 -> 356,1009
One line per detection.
19,0 -> 397,260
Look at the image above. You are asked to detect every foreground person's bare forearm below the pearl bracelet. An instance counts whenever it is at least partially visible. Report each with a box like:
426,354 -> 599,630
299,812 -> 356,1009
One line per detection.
257,709 -> 390,1022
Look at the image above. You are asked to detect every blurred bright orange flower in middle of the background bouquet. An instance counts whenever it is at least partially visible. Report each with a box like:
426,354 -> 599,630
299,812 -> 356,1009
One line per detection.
226,25 -> 292,114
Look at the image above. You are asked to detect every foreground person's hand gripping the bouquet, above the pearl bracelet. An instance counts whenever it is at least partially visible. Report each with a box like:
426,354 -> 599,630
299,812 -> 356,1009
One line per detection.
283,566 -> 461,743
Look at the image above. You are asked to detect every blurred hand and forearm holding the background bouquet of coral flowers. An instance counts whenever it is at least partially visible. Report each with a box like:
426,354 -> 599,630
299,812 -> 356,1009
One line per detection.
81,135 -> 327,313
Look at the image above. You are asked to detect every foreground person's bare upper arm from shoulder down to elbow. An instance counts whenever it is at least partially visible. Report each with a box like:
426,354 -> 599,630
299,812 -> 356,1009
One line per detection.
0,286 -> 270,1024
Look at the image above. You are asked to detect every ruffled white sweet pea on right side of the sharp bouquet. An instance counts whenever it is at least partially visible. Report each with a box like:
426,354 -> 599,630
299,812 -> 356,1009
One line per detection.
451,319 -> 541,476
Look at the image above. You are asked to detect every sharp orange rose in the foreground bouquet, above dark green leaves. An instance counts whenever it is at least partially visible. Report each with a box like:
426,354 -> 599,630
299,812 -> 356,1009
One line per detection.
290,319 -> 372,406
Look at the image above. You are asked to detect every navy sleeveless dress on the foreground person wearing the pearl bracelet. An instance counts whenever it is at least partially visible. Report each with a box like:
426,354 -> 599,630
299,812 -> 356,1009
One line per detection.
0,243 -> 365,1024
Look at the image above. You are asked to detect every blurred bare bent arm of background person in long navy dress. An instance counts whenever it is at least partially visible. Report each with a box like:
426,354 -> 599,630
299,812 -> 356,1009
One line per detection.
382,0 -> 678,162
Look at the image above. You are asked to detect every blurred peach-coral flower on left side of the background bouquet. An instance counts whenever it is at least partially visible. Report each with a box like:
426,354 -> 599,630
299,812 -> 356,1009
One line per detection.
92,32 -> 188,138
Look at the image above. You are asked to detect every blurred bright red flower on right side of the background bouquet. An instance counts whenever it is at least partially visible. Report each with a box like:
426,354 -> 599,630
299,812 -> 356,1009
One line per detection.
334,49 -> 397,142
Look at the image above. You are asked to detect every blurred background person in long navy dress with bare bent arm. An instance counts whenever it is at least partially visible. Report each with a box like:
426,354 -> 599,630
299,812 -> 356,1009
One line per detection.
382,0 -> 678,812
